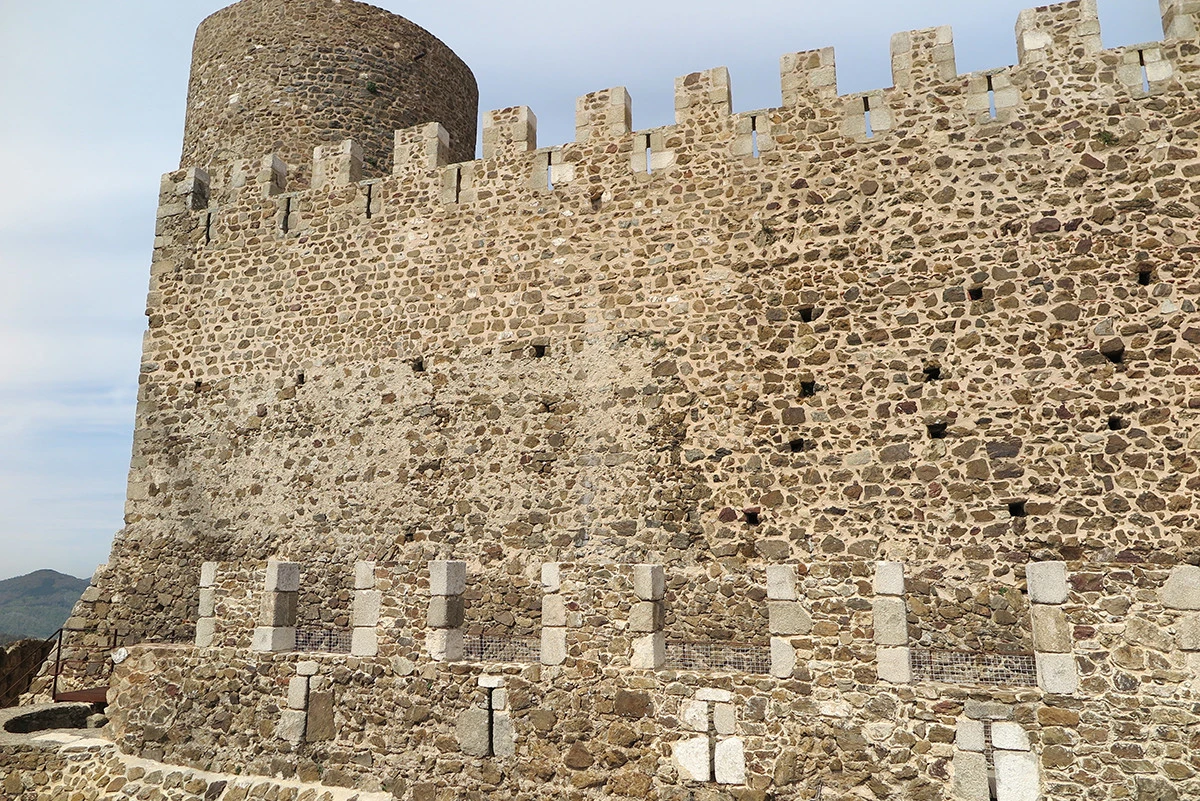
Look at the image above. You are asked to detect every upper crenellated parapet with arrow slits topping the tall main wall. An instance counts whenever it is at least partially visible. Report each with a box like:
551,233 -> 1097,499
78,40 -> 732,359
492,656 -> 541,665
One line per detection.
166,0 -> 1196,231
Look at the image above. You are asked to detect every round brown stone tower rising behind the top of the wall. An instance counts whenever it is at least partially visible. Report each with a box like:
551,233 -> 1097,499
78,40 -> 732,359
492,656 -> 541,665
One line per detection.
181,0 -> 479,176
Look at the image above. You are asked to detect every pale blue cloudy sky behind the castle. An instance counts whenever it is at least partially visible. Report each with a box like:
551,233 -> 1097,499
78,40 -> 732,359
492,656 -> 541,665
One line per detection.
0,0 -> 1162,579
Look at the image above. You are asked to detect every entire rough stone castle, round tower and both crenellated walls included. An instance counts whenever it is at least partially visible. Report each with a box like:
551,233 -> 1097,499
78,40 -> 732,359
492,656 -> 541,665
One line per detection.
7,0 -> 1200,801
